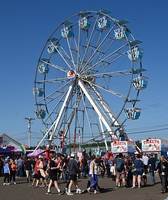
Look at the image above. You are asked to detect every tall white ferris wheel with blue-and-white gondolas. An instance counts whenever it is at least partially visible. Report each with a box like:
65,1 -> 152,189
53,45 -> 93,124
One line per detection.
34,10 -> 148,150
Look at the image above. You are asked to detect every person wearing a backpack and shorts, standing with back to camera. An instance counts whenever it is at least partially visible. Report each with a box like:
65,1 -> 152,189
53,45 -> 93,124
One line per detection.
114,153 -> 127,188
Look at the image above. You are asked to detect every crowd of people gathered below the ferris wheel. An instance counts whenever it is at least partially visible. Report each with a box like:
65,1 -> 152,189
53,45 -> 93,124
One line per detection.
0,153 -> 168,195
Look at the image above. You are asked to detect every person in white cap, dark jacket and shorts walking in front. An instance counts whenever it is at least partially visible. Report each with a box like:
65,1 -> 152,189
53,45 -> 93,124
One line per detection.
67,153 -> 81,195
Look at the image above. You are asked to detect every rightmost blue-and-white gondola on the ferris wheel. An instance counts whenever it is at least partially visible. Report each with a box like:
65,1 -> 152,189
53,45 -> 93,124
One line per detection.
132,76 -> 148,90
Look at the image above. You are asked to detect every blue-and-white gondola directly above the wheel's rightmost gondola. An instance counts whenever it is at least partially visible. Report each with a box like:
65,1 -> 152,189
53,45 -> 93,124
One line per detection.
127,47 -> 144,62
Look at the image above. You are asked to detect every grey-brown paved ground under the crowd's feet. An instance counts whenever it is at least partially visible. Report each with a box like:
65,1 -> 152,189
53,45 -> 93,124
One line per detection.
0,177 -> 168,200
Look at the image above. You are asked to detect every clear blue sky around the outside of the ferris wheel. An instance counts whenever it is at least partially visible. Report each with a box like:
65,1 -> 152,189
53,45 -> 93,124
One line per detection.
0,0 -> 168,145
